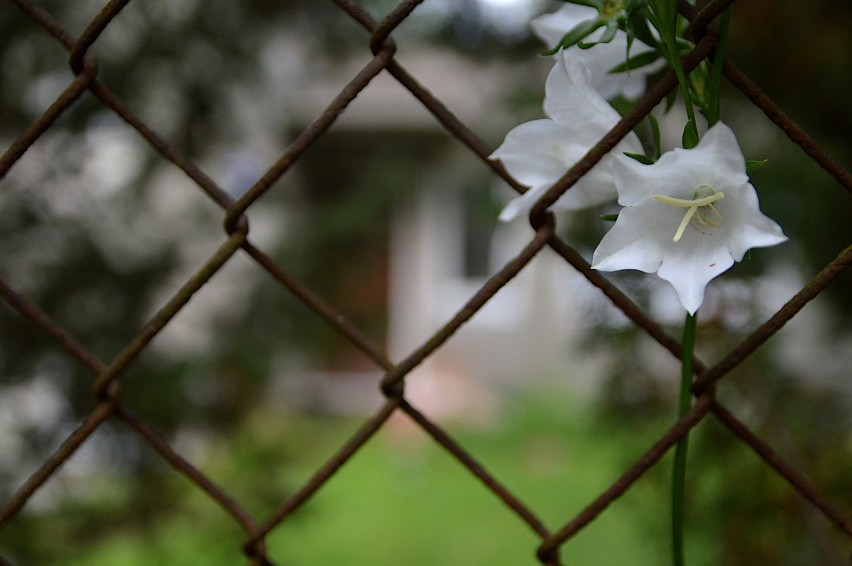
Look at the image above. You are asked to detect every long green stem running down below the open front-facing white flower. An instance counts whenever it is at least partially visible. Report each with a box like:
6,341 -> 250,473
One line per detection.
672,313 -> 697,566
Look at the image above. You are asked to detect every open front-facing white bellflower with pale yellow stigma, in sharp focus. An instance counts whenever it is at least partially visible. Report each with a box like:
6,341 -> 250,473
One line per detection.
592,123 -> 787,314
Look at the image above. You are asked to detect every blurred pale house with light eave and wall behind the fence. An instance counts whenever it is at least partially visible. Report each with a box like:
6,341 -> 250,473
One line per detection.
272,46 -> 596,420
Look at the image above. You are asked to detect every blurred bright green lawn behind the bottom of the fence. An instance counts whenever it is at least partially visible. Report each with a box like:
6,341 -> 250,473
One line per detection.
0,386 -> 712,566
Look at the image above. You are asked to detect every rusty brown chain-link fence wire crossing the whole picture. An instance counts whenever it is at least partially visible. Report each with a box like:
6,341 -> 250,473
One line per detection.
0,0 -> 852,564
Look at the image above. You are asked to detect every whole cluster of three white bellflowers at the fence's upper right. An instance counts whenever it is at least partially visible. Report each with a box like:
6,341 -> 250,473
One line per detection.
491,4 -> 787,314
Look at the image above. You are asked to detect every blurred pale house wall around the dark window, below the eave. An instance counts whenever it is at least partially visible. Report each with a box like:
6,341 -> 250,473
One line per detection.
388,153 -> 598,420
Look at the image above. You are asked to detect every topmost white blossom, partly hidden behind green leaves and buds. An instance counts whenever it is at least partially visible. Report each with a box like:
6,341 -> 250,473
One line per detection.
530,4 -> 665,100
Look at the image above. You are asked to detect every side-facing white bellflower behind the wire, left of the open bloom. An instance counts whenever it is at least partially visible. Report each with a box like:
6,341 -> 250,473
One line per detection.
490,52 -> 643,220
